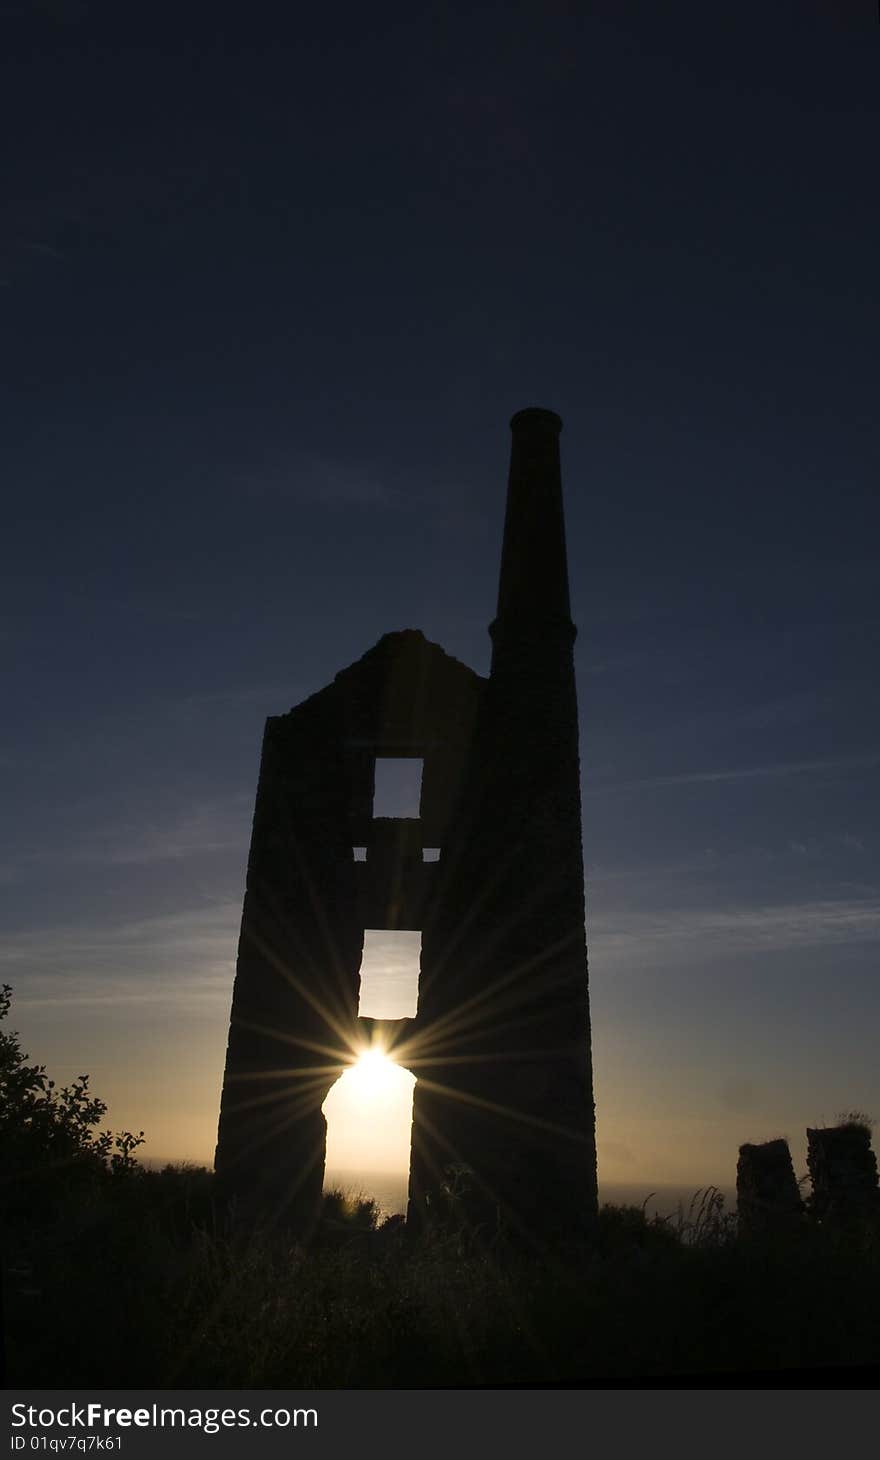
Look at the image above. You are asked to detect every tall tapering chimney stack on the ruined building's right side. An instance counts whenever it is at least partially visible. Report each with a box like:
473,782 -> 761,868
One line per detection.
486,407 -> 597,1229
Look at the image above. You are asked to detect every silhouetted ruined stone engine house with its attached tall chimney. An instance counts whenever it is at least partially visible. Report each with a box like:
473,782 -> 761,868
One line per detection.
216,409 -> 597,1238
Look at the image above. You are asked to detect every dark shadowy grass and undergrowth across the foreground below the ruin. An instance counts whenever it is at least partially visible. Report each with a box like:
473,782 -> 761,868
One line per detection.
4,1168 -> 880,1388
